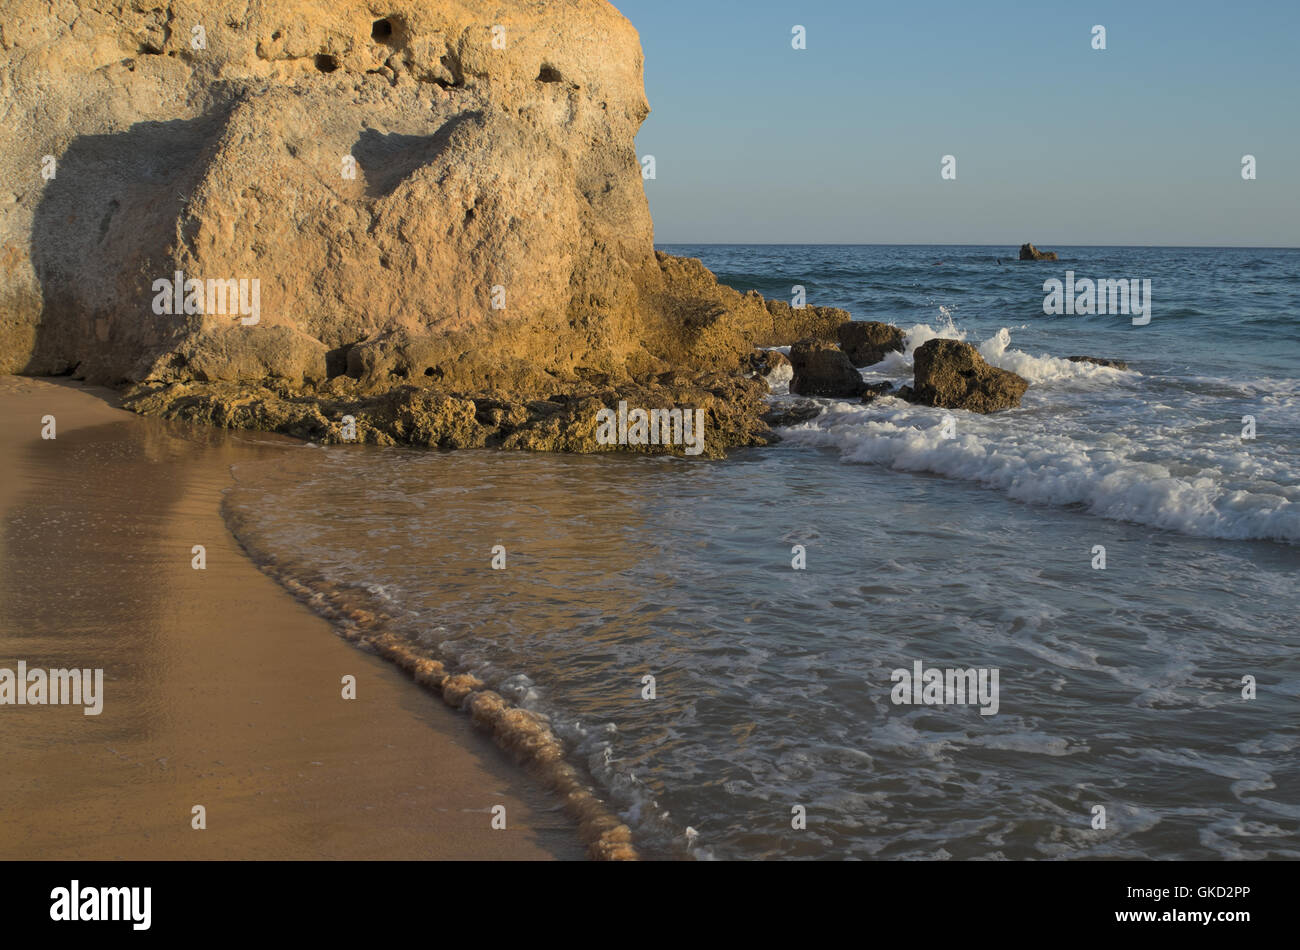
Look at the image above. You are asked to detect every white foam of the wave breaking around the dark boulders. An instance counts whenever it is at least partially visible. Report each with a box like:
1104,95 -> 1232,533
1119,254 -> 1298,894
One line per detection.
783,326 -> 1300,542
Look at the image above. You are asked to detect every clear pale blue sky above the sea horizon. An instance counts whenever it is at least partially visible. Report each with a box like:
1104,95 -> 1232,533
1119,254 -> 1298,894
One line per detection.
614,0 -> 1300,247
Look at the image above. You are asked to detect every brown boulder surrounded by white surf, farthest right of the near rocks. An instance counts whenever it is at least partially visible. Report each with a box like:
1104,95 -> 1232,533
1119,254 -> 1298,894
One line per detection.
905,339 -> 1030,412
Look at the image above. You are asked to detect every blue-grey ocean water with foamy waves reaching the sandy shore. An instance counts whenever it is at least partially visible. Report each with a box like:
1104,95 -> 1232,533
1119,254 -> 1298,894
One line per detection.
218,246 -> 1300,859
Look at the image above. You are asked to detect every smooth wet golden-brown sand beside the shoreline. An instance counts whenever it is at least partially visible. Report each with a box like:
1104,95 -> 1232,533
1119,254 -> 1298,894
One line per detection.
0,377 -> 582,859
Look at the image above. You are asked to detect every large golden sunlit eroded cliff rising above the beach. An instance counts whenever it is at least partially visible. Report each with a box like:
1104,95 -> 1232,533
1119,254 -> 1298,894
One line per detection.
0,0 -> 848,452
